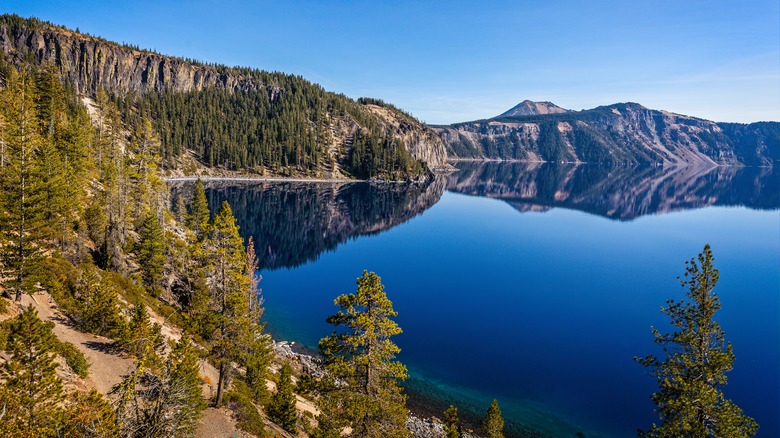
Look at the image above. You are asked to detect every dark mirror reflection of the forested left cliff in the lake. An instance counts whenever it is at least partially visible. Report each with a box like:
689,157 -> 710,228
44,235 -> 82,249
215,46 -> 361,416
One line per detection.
169,179 -> 445,270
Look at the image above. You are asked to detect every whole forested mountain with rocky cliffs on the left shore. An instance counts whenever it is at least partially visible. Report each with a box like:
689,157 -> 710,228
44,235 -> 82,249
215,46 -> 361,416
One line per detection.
0,15 -> 448,179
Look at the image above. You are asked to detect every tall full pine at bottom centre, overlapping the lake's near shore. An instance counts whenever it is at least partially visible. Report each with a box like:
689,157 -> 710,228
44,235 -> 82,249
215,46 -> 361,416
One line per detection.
320,271 -> 409,437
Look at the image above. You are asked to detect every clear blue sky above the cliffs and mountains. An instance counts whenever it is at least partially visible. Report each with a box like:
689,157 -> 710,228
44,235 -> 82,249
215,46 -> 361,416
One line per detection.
0,0 -> 780,123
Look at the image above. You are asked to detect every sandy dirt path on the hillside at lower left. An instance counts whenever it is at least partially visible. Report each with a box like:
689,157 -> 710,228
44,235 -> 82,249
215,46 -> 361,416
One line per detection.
22,292 -> 133,394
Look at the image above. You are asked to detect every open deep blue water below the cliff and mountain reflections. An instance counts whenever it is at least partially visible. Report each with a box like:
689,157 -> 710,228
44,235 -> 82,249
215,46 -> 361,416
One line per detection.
198,165 -> 780,437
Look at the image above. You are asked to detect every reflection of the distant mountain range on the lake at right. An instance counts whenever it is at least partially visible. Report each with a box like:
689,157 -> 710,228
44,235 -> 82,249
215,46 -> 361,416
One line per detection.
447,162 -> 780,220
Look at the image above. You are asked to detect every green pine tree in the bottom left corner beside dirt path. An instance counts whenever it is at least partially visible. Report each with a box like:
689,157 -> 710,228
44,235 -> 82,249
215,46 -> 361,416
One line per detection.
0,306 -> 65,437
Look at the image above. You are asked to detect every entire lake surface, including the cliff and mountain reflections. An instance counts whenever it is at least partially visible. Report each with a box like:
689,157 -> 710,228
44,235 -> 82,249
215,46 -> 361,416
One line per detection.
184,163 -> 780,437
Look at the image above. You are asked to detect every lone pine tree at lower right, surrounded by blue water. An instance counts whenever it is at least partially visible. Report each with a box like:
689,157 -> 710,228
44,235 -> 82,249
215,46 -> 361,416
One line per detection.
634,245 -> 758,438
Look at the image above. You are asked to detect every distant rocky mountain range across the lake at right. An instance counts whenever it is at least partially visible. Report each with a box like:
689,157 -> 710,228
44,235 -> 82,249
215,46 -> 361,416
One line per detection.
433,101 -> 780,166
